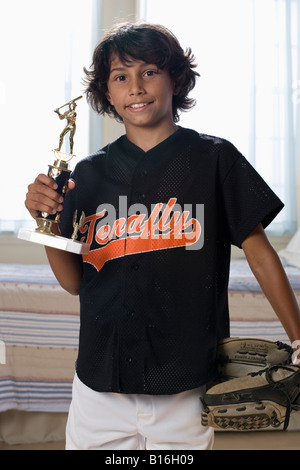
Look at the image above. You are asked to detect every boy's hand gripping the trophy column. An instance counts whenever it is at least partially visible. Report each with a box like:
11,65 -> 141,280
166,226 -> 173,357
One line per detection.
25,174 -> 75,219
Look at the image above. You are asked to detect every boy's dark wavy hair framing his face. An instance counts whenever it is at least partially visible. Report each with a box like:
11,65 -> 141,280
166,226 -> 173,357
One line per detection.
84,23 -> 199,122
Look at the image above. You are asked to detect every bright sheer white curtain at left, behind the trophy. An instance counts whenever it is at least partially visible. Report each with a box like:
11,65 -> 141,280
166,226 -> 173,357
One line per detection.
0,0 -> 101,233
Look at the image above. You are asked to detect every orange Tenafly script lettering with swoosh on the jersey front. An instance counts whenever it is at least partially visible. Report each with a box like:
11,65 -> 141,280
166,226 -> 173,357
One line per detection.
80,196 -> 203,271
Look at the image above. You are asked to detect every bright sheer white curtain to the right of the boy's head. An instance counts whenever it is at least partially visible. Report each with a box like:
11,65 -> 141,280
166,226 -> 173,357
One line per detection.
140,0 -> 300,235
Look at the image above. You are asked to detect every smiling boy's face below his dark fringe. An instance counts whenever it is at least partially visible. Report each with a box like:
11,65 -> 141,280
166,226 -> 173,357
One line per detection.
106,57 -> 174,136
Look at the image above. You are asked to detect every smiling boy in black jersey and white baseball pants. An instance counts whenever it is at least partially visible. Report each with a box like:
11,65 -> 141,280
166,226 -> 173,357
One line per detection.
26,24 -> 300,450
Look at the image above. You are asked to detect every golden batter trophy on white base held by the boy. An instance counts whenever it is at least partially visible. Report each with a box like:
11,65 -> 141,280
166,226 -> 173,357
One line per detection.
18,96 -> 90,254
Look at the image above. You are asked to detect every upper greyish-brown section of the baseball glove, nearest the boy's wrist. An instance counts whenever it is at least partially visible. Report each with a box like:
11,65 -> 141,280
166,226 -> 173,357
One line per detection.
217,337 -> 293,381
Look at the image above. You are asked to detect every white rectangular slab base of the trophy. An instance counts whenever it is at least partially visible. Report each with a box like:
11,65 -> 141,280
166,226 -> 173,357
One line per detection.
18,228 -> 90,255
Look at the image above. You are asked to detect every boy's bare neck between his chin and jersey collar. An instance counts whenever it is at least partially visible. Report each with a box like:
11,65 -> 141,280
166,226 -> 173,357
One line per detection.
125,122 -> 178,152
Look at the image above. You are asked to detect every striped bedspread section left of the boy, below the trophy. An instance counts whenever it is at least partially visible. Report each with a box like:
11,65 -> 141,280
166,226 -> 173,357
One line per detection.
0,264 -> 79,412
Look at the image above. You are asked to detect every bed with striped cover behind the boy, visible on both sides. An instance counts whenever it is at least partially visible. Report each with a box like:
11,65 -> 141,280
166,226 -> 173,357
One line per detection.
0,248 -> 300,443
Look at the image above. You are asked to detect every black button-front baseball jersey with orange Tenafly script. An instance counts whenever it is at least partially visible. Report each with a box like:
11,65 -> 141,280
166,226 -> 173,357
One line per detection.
61,127 -> 283,395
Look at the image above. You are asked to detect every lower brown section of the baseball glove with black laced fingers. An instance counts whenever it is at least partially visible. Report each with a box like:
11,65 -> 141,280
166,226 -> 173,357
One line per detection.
201,365 -> 300,431
